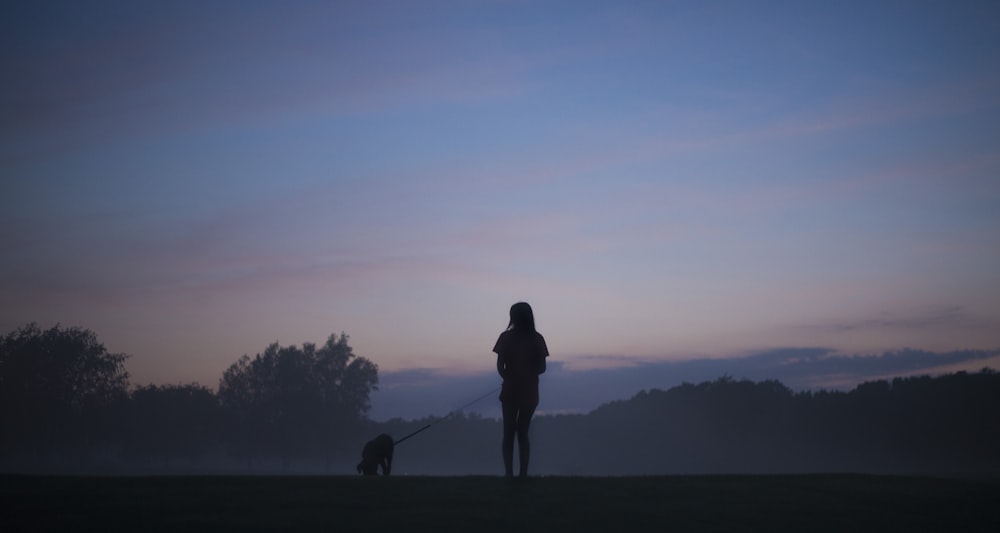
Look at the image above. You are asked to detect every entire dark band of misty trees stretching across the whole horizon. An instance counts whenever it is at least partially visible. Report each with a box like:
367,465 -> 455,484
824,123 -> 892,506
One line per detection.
0,324 -> 1000,475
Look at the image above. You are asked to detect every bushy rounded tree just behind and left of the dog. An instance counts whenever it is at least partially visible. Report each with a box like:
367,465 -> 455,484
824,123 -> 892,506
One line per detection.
219,333 -> 378,467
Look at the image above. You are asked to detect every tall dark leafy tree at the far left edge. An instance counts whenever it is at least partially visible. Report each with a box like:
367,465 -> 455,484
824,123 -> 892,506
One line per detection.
0,323 -> 128,464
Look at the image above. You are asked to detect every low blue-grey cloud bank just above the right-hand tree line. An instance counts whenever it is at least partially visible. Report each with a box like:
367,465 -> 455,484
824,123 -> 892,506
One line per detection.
369,348 -> 1000,422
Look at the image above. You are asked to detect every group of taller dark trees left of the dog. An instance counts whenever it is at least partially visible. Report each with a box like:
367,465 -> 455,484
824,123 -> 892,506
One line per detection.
0,324 -> 378,472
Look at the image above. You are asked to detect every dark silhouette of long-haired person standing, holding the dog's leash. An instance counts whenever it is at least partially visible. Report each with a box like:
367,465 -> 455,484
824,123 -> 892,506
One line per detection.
493,302 -> 549,479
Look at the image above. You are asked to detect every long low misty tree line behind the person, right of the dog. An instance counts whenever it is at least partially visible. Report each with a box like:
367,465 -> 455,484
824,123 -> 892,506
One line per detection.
380,369 -> 1000,475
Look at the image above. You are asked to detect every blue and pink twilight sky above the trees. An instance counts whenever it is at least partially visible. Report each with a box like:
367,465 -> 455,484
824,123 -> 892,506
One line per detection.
0,0 -> 1000,418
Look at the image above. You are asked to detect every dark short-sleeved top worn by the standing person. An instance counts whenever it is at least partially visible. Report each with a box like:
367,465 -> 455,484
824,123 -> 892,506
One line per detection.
493,329 -> 549,407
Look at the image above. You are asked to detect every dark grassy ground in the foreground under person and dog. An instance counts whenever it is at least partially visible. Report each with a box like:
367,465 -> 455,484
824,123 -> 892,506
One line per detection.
0,474 -> 1000,532
